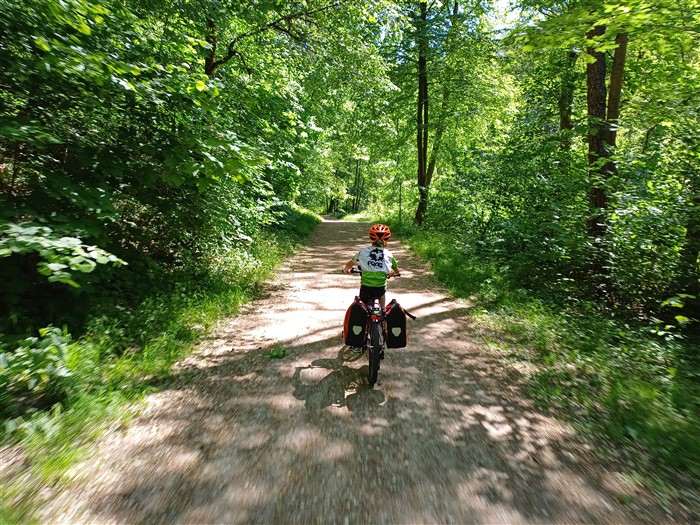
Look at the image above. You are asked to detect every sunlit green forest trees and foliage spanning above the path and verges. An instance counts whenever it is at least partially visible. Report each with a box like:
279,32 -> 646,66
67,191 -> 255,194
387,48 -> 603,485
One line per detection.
0,0 -> 700,313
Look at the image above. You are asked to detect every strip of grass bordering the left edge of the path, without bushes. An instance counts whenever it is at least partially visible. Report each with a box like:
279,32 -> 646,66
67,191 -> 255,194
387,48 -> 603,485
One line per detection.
0,207 -> 321,525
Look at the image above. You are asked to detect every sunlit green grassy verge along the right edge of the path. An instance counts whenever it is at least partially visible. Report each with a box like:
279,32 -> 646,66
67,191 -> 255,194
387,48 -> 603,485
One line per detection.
398,229 -> 700,496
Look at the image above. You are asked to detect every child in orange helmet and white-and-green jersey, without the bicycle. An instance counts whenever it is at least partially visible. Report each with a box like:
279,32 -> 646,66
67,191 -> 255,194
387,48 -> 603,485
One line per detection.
343,224 -> 401,308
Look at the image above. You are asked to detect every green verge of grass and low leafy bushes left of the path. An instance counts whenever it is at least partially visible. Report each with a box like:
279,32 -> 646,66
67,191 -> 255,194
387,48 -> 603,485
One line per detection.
0,204 -> 320,523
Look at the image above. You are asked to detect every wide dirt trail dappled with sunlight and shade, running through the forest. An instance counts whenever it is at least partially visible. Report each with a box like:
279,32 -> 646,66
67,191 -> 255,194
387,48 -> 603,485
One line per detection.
42,221 -> 664,524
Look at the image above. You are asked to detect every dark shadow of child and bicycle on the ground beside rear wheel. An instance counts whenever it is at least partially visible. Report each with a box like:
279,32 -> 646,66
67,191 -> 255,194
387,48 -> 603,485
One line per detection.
292,349 -> 386,411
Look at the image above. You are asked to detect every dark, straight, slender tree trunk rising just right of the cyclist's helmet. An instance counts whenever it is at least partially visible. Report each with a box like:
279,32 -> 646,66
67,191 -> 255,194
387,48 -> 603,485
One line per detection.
415,2 -> 429,225
